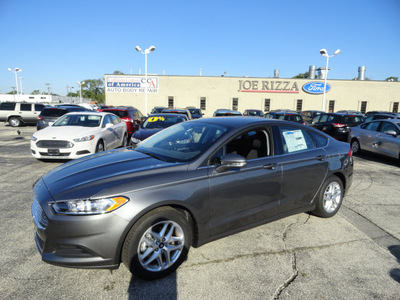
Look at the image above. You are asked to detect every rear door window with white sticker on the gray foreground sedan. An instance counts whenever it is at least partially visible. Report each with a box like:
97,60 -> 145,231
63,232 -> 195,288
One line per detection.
279,126 -> 315,154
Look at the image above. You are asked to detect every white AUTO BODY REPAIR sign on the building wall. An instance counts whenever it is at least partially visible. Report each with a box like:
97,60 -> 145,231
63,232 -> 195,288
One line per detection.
106,76 -> 158,93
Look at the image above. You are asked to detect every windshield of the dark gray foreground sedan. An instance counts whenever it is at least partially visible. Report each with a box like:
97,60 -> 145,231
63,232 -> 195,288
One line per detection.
135,122 -> 230,162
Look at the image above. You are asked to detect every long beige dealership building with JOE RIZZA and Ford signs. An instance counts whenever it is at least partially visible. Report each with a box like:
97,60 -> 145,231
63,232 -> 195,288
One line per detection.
105,66 -> 400,117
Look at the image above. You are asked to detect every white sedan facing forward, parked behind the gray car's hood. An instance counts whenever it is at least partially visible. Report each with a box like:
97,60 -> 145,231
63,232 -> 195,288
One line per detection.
31,112 -> 128,159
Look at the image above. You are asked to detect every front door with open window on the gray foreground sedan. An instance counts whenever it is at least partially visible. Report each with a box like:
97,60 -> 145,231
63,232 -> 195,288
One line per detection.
209,128 -> 282,236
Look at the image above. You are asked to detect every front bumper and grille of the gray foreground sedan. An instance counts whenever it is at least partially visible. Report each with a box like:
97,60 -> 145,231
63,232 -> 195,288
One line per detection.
32,188 -> 129,269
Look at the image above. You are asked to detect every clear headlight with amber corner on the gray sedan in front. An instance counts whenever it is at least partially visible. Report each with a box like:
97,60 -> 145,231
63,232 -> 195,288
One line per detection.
52,197 -> 129,215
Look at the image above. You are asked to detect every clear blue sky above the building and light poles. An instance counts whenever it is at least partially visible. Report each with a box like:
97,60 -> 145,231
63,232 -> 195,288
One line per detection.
0,0 -> 400,95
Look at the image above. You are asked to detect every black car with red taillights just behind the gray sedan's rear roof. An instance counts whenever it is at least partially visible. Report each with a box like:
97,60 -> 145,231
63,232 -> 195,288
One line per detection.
310,113 -> 365,142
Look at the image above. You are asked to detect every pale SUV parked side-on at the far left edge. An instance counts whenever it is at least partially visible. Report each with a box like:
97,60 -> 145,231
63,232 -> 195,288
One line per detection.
0,102 -> 45,127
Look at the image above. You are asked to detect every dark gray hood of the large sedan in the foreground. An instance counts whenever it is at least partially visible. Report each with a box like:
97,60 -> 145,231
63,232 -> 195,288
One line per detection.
42,148 -> 187,201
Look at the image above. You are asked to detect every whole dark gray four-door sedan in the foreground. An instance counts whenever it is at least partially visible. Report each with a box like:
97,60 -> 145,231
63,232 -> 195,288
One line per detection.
32,117 -> 353,280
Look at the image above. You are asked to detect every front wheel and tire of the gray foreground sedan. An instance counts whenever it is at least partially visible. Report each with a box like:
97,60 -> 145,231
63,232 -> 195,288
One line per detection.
122,206 -> 192,280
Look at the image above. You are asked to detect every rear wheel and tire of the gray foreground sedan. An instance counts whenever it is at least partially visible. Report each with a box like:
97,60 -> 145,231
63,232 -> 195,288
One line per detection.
311,175 -> 344,218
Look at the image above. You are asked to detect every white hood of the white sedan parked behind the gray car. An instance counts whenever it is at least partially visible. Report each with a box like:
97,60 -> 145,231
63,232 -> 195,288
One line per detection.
33,126 -> 100,140
